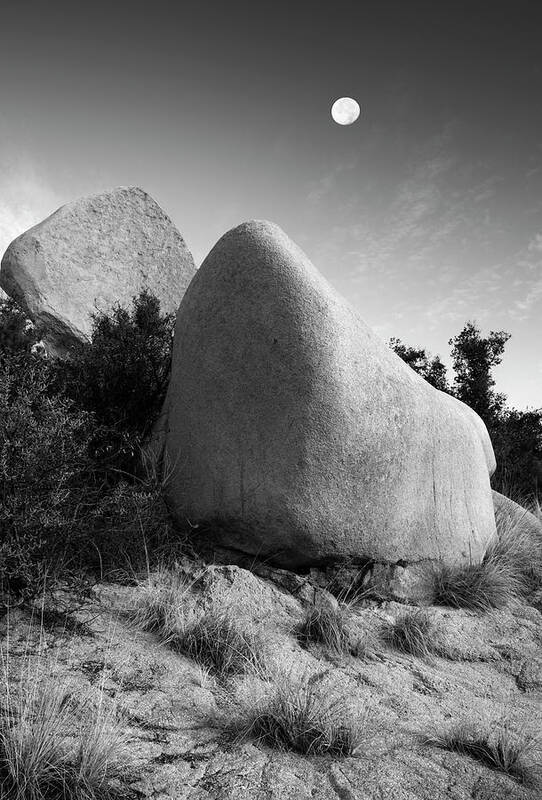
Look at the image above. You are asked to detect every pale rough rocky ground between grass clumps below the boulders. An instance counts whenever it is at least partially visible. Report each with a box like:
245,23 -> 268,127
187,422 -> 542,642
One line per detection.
2,566 -> 542,800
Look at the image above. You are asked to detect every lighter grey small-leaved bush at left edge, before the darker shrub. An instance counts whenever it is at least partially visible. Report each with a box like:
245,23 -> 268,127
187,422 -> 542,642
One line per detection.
0,354 -> 96,597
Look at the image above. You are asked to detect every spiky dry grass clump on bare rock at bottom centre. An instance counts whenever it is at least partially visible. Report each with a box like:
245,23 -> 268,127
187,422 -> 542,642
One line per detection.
232,674 -> 365,756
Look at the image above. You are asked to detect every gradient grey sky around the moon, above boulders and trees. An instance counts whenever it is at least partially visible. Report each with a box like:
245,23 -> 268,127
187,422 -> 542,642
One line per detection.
0,0 -> 542,409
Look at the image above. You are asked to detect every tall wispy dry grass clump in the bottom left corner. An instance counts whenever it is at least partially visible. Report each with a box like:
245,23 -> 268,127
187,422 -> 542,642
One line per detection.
0,675 -> 123,800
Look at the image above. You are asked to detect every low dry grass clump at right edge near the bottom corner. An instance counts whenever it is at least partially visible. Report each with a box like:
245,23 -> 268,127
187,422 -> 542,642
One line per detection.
425,722 -> 541,787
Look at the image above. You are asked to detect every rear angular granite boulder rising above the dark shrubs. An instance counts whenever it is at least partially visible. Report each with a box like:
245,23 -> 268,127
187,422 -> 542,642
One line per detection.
0,187 -> 196,354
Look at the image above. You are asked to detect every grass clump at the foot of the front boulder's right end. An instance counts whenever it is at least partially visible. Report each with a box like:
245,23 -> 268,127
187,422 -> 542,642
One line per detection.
433,558 -> 521,612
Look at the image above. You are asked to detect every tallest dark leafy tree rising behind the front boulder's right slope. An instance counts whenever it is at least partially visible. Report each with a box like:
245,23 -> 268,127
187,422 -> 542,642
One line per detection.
448,322 -> 510,430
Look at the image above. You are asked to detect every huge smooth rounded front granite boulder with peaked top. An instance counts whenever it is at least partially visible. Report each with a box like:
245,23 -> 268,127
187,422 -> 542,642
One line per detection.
157,221 -> 495,568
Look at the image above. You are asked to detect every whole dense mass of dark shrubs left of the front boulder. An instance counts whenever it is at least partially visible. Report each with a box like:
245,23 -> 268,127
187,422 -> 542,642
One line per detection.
0,294 -> 178,600
